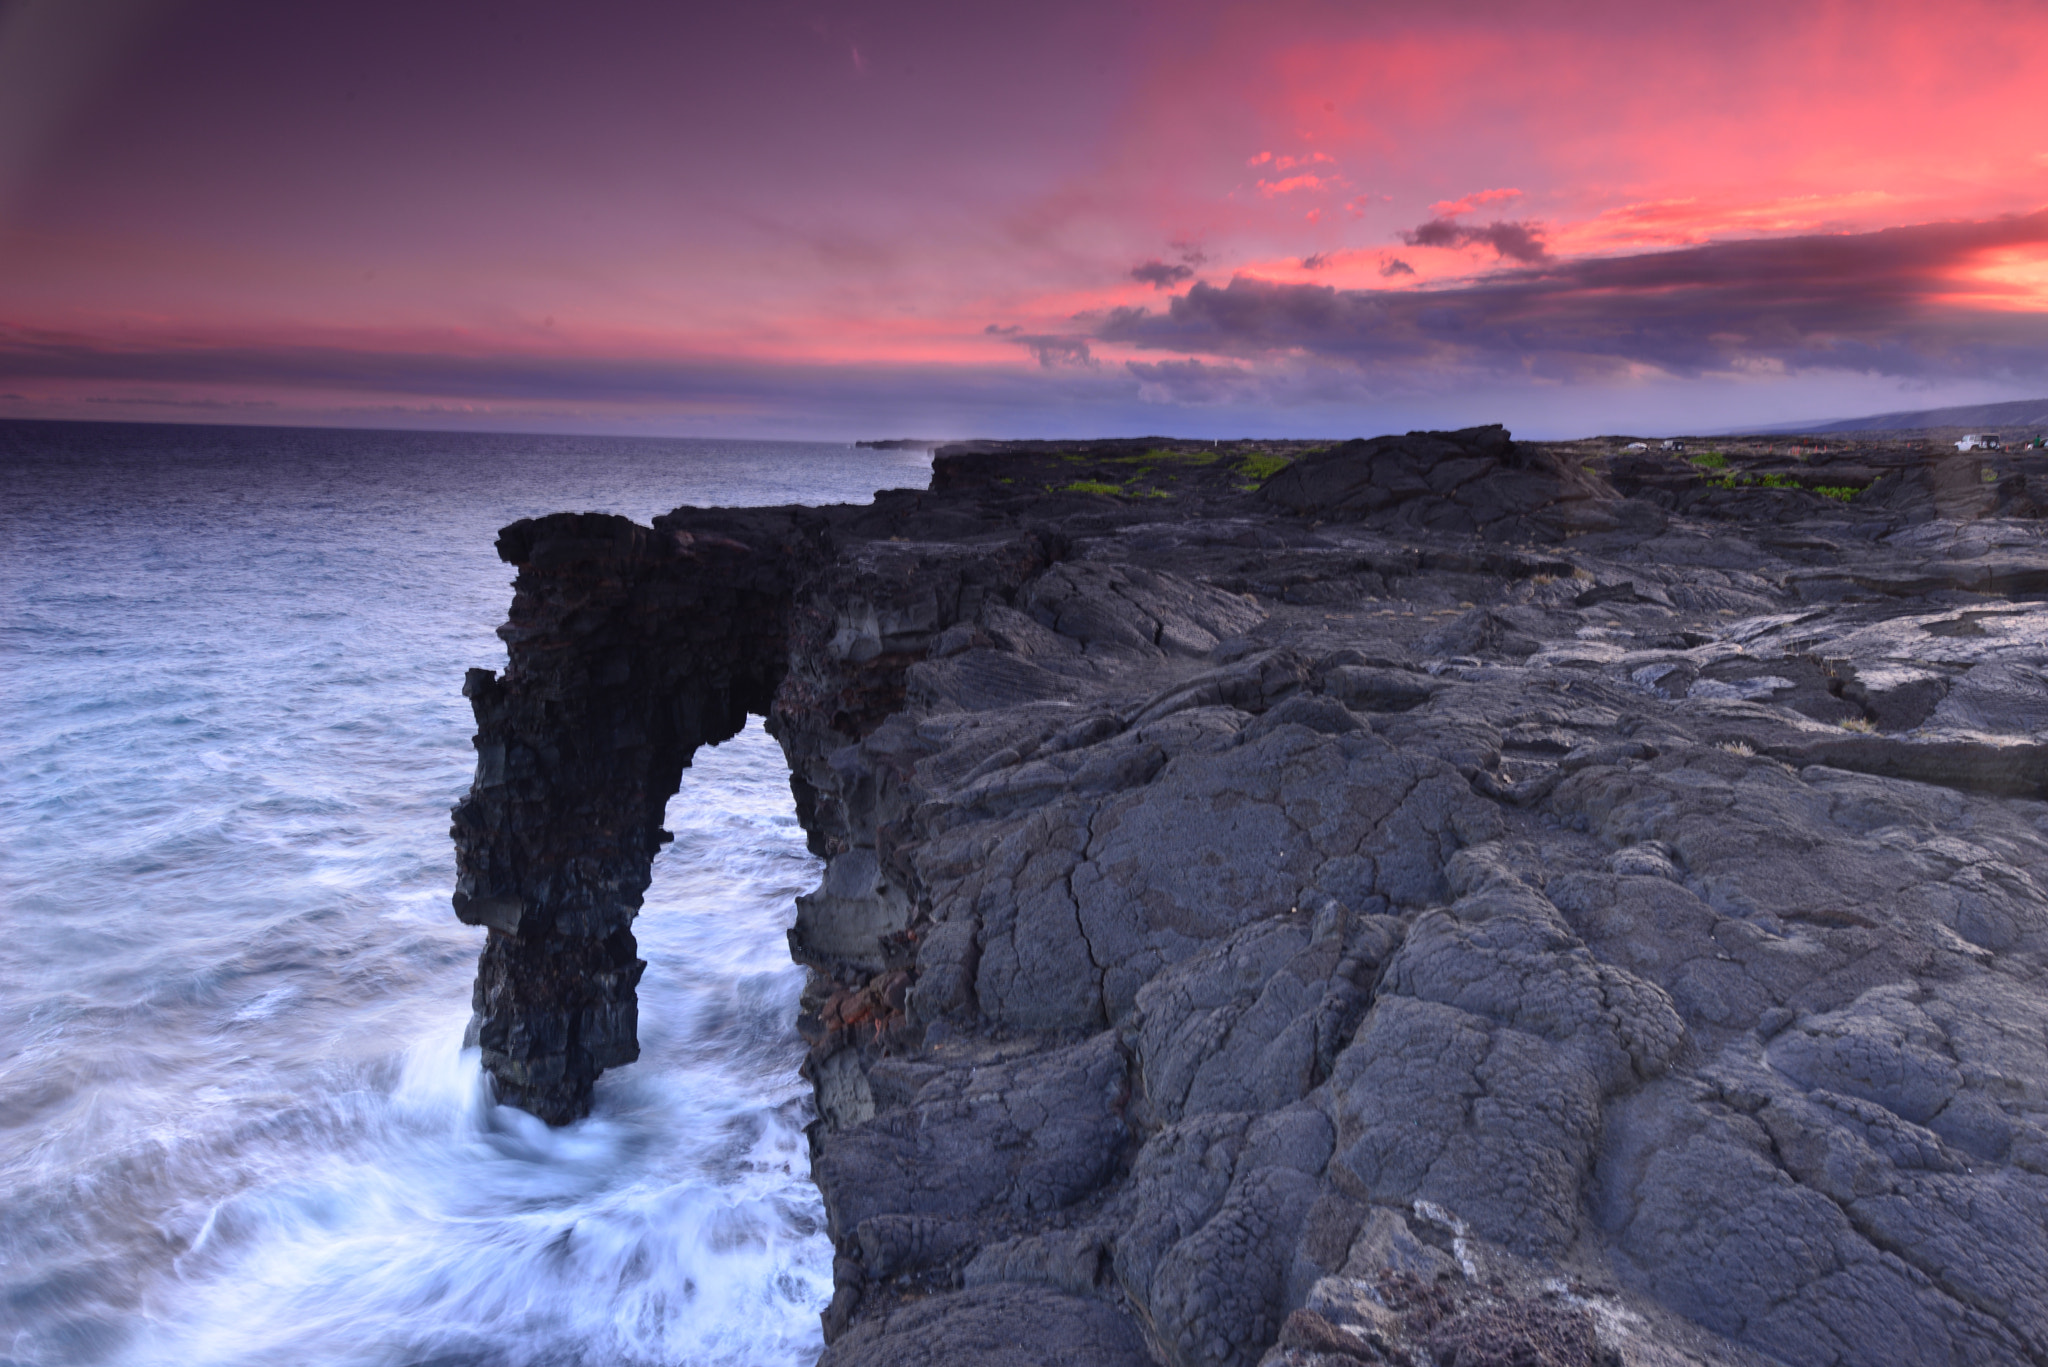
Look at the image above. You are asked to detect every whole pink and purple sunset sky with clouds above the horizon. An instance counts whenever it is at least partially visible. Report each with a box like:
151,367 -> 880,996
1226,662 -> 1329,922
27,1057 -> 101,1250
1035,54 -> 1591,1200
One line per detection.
0,0 -> 2048,441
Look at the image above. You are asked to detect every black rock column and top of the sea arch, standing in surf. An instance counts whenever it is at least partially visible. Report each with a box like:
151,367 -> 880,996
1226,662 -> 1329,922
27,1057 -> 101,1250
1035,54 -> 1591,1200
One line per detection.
451,508 -> 825,1125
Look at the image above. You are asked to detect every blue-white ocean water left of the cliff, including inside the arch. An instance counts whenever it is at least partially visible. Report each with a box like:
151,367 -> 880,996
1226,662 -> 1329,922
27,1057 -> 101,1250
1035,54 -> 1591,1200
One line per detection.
0,424 -> 930,1367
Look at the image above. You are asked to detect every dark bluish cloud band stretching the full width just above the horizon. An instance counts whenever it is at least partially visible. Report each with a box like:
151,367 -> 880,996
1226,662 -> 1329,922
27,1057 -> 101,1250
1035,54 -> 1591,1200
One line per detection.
0,211 -> 2048,432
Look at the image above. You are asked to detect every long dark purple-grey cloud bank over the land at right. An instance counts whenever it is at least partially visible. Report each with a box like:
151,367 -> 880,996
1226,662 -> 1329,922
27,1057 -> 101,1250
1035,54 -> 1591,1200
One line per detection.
1087,211 -> 2048,379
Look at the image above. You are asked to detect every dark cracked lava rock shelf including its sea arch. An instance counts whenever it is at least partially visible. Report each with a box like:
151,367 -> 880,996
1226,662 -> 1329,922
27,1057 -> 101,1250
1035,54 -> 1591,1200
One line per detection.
455,428 -> 2048,1367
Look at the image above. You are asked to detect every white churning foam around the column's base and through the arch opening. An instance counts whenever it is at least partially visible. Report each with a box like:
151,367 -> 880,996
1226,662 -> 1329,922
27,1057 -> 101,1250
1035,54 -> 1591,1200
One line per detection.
97,730 -> 831,1367
